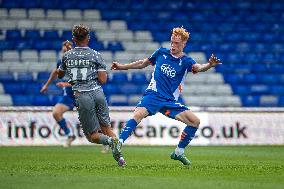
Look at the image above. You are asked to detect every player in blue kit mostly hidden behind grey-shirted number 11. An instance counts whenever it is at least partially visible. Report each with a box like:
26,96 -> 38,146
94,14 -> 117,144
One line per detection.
40,41 -> 75,147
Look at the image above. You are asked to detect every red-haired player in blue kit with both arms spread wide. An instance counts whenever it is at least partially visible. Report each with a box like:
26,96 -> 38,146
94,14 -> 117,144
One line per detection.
111,27 -> 221,165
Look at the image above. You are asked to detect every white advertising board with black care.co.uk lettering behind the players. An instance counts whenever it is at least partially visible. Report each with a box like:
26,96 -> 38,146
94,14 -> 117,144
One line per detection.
0,107 -> 284,146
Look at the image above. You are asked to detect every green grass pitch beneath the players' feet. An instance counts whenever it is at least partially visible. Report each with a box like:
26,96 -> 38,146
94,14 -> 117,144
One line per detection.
0,146 -> 284,189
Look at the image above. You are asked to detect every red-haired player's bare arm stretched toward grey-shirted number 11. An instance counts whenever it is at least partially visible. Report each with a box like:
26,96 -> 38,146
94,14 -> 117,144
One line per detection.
111,58 -> 151,70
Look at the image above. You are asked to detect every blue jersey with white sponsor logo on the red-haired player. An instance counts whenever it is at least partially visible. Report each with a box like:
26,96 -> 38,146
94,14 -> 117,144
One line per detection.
146,48 -> 196,100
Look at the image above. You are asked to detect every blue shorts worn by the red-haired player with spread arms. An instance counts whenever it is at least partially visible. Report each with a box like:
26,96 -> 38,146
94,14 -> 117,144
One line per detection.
137,92 -> 189,119
